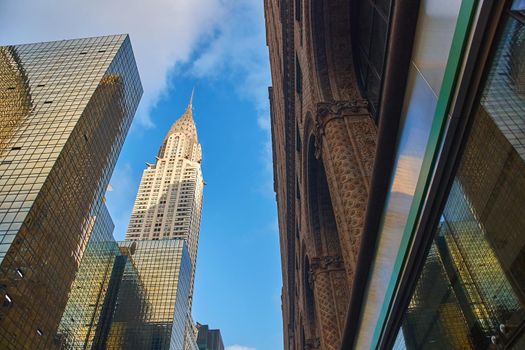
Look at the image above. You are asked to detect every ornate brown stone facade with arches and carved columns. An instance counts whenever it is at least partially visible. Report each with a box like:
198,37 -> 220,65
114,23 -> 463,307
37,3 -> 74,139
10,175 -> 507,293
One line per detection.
265,0 -> 376,350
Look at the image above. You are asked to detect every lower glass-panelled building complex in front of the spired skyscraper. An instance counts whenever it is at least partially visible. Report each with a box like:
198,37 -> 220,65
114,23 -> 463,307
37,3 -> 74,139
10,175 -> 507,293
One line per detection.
57,220 -> 191,349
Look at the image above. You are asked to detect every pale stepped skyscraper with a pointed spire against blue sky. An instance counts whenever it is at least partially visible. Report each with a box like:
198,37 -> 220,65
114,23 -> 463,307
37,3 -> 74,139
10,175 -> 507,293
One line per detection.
126,94 -> 204,299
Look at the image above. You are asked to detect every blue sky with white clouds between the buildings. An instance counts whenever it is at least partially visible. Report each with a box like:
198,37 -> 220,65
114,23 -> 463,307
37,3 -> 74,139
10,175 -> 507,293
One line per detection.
0,0 -> 283,350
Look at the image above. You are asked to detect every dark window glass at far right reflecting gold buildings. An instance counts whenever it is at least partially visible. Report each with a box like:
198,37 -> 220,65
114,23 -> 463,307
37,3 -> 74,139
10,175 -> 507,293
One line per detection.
395,9 -> 525,349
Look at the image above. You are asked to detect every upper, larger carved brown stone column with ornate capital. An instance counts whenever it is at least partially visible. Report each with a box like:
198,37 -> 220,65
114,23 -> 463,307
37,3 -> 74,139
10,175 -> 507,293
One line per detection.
315,99 -> 377,286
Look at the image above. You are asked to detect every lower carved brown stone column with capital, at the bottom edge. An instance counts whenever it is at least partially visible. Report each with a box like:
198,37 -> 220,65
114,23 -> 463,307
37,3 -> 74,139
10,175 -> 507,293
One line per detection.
309,256 -> 349,350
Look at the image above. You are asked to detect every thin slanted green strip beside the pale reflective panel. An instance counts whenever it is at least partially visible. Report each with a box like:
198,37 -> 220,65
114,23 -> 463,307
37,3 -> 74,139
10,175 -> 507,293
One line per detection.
370,0 -> 478,349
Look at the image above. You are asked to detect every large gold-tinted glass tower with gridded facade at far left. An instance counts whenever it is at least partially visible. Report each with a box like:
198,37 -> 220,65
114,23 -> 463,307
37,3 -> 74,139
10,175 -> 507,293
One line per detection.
0,35 -> 142,349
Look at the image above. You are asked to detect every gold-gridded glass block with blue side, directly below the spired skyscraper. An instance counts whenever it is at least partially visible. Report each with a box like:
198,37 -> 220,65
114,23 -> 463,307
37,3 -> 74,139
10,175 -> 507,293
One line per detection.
104,239 -> 191,349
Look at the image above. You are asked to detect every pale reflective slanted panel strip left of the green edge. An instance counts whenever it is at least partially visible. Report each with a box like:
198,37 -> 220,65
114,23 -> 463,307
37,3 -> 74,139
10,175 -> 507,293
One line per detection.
357,0 -> 461,349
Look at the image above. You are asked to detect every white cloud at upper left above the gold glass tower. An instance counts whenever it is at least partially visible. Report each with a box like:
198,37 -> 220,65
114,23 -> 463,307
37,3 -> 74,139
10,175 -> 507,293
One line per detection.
0,0 -> 225,127
